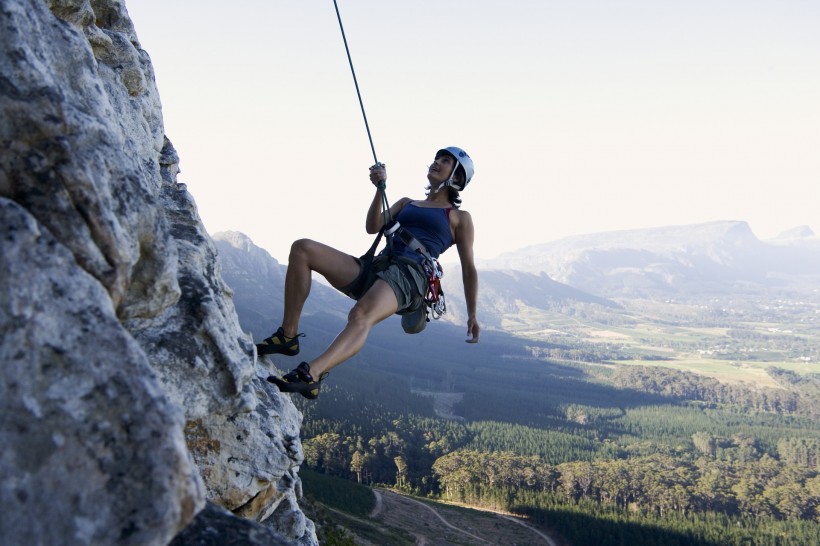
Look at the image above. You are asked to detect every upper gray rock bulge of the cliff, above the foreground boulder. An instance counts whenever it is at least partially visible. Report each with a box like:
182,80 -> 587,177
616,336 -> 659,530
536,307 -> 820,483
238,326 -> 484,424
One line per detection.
0,0 -> 179,317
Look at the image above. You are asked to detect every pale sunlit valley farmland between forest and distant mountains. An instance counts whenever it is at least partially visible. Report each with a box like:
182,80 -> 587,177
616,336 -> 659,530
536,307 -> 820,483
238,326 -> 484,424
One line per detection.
507,302 -> 820,388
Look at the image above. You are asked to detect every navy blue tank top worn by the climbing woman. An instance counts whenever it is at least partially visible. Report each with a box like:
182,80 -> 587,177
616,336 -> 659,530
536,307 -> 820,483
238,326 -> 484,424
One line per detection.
382,203 -> 453,262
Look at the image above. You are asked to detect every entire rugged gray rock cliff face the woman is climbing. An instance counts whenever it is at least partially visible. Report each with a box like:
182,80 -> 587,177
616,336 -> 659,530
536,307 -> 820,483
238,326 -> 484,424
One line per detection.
0,0 -> 317,545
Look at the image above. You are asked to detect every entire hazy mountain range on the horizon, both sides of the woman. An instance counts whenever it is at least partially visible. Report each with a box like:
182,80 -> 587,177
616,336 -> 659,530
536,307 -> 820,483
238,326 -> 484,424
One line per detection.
213,221 -> 820,341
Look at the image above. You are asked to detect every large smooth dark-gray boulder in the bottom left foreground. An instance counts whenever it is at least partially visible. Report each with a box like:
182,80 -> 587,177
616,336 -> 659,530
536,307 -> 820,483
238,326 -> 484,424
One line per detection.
0,198 -> 204,545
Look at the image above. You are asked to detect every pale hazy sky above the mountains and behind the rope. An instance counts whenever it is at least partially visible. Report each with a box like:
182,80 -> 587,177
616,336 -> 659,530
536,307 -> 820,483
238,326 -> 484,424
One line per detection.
126,0 -> 820,262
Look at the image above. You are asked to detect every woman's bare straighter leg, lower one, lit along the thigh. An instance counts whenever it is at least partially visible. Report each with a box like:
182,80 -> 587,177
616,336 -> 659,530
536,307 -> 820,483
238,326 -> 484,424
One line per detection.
310,279 -> 398,380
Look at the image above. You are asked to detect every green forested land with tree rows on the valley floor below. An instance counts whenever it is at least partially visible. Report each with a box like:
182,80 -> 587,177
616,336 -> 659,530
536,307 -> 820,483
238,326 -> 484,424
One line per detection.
297,359 -> 820,545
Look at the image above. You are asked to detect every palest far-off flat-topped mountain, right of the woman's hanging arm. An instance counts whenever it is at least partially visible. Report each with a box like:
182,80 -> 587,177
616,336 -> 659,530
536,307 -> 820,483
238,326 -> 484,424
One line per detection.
479,221 -> 820,300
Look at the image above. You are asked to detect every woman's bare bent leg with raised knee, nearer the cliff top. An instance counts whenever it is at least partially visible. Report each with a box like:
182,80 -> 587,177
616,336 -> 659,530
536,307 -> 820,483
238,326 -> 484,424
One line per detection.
282,239 -> 361,337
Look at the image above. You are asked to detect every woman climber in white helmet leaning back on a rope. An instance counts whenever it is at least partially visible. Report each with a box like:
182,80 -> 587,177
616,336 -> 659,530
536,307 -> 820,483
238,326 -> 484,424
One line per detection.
256,147 -> 481,398
